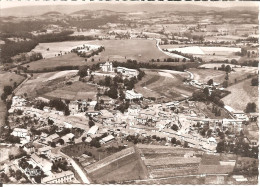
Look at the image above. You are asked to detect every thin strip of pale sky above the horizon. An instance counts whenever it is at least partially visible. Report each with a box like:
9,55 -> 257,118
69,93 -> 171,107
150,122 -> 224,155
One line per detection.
0,0 -> 259,8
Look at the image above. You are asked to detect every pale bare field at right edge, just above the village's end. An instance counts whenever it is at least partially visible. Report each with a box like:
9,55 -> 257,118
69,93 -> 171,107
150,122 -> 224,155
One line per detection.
222,79 -> 259,111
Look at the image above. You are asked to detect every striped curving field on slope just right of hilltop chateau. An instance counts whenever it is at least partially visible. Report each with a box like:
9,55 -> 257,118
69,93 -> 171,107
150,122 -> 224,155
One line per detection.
135,70 -> 194,100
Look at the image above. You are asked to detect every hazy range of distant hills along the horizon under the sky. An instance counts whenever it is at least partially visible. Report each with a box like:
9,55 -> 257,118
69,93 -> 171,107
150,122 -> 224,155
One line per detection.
0,2 -> 258,17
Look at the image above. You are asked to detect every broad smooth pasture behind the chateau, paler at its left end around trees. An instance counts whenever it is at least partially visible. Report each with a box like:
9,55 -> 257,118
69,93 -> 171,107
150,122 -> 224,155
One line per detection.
33,39 -> 168,62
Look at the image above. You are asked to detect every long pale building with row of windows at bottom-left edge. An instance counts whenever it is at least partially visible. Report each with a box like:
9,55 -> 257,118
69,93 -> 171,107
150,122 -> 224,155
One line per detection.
41,170 -> 75,184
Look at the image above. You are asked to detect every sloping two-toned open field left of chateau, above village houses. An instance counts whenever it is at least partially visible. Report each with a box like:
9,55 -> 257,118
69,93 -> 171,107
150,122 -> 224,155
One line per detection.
17,71 -> 97,100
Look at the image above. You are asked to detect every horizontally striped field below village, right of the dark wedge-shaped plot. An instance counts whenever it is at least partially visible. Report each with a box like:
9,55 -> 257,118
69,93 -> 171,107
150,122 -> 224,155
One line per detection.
137,144 -> 202,178
